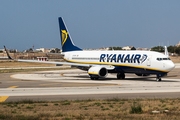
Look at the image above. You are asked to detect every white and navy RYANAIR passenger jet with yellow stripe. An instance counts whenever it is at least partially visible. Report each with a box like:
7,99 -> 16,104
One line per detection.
4,17 -> 175,81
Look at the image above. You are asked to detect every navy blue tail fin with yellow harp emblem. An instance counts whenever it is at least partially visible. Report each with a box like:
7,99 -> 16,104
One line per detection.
59,17 -> 82,52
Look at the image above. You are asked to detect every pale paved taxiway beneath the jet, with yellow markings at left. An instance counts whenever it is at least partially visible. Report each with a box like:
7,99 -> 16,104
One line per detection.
0,64 -> 180,102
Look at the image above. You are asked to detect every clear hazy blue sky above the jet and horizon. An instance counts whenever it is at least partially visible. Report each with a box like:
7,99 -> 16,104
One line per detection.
0,0 -> 180,51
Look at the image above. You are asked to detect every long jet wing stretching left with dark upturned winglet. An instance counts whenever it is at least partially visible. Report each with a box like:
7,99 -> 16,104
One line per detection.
4,46 -> 114,70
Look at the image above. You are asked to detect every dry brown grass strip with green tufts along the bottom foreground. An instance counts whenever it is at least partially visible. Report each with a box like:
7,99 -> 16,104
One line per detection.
0,98 -> 180,120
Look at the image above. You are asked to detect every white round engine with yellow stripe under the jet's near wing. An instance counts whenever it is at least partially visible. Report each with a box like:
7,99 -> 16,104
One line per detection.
88,66 -> 108,78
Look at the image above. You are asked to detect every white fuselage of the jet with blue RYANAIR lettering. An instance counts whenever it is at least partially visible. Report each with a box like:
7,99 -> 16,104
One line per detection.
64,51 -> 175,73
